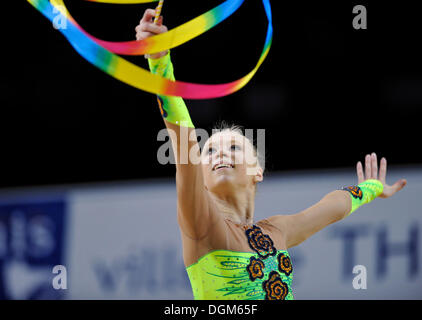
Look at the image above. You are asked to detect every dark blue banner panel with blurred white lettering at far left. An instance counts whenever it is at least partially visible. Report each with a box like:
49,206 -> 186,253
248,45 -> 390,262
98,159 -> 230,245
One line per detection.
0,200 -> 66,299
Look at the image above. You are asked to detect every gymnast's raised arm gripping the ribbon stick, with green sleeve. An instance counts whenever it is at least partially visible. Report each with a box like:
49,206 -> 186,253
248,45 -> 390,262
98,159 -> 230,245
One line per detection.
135,9 -> 218,239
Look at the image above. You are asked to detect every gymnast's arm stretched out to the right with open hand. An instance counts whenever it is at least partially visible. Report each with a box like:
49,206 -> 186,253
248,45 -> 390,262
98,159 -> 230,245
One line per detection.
271,153 -> 407,248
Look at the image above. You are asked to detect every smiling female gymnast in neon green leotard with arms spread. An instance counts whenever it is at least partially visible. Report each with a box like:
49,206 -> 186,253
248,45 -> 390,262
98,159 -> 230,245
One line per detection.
135,9 -> 406,300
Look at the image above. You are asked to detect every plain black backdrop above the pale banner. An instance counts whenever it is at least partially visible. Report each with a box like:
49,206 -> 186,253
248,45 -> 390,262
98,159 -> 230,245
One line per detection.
0,0 -> 422,188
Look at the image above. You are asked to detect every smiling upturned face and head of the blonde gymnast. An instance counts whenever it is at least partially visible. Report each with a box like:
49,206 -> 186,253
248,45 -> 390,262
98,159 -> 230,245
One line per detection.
201,130 -> 263,194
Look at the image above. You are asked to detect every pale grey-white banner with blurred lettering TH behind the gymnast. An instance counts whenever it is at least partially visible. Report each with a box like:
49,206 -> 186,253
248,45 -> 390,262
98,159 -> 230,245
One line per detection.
0,167 -> 422,299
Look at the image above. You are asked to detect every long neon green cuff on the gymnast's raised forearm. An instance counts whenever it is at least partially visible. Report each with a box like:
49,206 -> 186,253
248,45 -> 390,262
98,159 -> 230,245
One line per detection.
148,50 -> 195,128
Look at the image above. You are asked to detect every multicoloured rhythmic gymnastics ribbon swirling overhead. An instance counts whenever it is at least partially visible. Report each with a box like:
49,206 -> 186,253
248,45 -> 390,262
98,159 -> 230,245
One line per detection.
27,0 -> 273,99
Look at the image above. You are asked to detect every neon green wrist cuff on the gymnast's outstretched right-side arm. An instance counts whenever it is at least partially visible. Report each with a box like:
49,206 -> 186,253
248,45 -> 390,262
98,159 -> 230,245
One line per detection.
341,179 -> 384,215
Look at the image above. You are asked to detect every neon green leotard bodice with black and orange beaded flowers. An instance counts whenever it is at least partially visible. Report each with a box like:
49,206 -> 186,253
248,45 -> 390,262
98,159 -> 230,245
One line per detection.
186,225 -> 294,300
